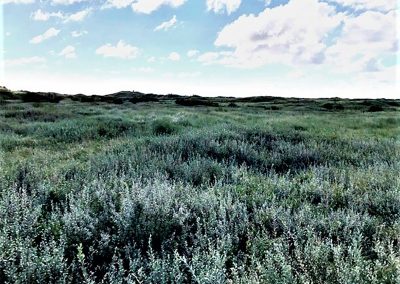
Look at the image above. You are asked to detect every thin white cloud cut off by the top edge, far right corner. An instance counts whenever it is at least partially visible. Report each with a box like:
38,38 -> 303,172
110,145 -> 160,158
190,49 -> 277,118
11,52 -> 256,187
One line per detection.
328,0 -> 396,12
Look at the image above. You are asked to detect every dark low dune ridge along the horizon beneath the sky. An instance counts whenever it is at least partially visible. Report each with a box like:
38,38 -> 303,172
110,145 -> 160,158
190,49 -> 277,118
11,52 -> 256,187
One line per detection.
0,86 -> 400,112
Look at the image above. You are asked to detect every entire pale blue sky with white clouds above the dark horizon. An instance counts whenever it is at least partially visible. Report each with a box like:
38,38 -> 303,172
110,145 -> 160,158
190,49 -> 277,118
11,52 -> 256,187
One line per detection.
0,0 -> 400,98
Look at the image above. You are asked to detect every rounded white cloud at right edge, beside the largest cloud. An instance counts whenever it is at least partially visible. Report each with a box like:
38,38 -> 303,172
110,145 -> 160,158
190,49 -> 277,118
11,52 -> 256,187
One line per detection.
326,11 -> 398,72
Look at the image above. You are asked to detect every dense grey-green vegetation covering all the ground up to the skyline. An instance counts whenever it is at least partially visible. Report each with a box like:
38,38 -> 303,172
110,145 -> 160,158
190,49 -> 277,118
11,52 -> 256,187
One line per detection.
0,90 -> 400,283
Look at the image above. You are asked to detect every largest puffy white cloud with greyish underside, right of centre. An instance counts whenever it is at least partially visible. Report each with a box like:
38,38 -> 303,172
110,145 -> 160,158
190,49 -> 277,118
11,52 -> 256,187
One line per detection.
203,0 -> 344,68
